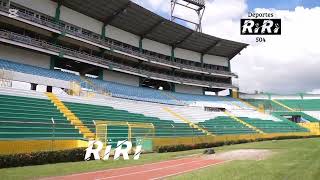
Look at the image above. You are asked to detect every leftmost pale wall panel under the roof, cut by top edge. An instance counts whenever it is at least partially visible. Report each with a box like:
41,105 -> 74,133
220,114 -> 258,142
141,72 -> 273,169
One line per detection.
11,0 -> 57,17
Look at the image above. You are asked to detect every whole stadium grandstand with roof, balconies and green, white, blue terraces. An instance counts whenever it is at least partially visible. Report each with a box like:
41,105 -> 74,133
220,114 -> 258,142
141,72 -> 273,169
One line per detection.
0,0 -> 320,154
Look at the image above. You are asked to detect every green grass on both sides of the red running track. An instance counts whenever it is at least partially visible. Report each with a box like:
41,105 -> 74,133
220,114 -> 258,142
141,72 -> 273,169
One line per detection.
0,138 -> 320,180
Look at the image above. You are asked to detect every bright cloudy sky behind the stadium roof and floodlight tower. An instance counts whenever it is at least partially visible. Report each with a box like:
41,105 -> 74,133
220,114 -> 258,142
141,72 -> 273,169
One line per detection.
134,0 -> 320,94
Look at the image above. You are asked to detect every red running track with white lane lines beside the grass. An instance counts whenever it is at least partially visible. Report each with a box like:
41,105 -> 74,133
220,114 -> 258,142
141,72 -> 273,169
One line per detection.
46,157 -> 224,180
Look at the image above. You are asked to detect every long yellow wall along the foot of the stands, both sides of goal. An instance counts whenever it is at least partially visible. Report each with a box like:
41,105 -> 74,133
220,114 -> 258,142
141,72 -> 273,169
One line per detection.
0,133 -> 319,154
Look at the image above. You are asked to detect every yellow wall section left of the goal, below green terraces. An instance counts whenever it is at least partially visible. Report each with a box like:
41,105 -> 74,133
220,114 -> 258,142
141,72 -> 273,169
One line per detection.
0,140 -> 88,154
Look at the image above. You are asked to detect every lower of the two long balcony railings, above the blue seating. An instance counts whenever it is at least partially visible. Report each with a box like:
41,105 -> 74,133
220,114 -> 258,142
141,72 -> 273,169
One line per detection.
0,30 -> 234,88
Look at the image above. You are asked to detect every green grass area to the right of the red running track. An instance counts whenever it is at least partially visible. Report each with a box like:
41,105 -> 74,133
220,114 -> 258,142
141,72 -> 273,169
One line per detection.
170,138 -> 320,180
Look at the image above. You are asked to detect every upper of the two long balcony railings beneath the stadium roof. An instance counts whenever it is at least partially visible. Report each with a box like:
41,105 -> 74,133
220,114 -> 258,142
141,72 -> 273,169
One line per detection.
0,3 -> 237,76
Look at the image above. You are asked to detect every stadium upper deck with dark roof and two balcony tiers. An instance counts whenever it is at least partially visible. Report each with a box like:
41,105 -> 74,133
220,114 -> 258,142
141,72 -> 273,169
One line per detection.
0,0 -> 247,92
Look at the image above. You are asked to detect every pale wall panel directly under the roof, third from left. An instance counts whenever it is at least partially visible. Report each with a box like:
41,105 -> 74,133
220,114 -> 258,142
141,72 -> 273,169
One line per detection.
106,25 -> 140,47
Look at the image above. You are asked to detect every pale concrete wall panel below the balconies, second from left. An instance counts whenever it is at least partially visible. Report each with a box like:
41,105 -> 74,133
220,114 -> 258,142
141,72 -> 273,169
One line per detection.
103,70 -> 139,86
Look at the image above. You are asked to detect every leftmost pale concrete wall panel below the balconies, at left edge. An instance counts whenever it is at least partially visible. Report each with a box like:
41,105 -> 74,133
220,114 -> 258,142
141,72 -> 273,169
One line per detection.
0,44 -> 50,69
